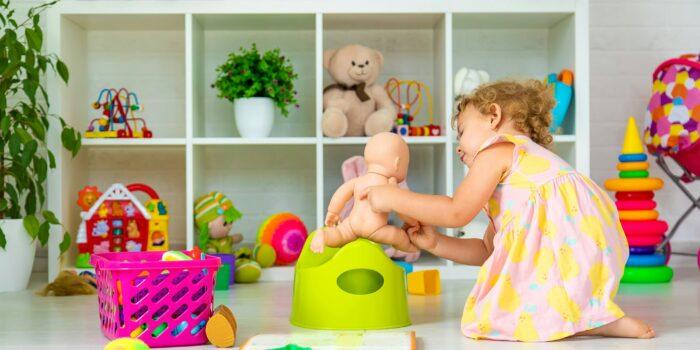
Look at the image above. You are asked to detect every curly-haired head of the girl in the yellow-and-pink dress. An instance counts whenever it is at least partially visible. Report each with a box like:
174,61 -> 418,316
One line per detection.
452,79 -> 555,165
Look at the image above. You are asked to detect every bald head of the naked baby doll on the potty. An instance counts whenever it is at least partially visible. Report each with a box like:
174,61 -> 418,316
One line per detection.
365,132 -> 409,182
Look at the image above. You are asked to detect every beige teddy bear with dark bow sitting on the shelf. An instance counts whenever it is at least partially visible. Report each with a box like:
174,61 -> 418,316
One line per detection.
321,45 -> 397,137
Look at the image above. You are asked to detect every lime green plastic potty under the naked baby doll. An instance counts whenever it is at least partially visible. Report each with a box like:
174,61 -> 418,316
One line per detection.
290,233 -> 411,330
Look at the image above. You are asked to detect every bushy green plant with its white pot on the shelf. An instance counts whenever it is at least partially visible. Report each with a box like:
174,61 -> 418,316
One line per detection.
212,44 -> 299,138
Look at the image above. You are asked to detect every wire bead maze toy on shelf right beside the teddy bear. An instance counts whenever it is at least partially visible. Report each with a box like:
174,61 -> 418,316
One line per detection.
384,78 -> 442,136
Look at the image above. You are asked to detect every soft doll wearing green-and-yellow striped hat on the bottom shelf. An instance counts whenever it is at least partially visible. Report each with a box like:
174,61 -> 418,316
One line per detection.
194,192 -> 243,254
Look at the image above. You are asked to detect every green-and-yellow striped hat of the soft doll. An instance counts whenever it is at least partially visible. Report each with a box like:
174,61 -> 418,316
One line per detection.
194,192 -> 243,249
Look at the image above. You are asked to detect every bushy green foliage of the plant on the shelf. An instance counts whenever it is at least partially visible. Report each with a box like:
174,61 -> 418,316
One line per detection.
212,44 -> 299,117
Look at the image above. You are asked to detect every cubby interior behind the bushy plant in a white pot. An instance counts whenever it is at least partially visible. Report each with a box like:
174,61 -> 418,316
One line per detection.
192,14 -> 316,138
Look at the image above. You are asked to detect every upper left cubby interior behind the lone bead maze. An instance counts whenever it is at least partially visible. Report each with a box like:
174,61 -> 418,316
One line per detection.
60,14 -> 185,138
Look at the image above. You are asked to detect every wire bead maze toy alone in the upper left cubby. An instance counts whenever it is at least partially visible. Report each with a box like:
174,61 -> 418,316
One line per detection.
85,88 -> 153,138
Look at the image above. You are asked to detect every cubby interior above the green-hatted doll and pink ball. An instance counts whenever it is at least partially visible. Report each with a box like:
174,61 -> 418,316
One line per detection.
193,145 -> 316,244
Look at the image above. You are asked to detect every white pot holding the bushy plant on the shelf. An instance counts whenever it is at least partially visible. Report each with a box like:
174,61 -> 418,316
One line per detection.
233,97 -> 275,138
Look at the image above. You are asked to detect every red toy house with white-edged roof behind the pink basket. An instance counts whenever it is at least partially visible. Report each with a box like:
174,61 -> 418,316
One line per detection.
76,183 -> 169,268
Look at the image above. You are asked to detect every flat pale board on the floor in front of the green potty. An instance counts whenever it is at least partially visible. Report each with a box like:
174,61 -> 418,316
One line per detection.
241,331 -> 417,350
